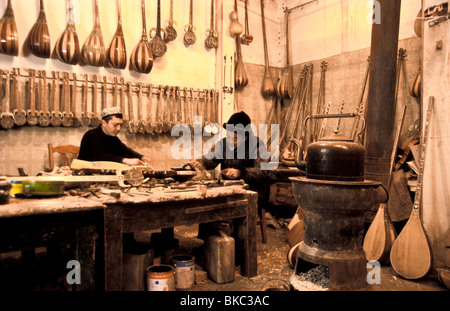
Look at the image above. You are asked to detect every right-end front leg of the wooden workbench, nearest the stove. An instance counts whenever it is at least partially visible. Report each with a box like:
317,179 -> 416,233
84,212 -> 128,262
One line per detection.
236,192 -> 258,277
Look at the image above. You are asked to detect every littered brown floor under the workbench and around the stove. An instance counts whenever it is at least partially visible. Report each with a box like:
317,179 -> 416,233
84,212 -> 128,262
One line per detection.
149,225 -> 448,291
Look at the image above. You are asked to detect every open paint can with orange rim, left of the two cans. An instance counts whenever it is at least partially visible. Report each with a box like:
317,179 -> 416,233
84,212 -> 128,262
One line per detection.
145,264 -> 175,292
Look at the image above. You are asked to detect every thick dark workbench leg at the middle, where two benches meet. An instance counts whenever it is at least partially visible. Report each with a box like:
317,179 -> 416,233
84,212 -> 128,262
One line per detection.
103,206 -> 123,291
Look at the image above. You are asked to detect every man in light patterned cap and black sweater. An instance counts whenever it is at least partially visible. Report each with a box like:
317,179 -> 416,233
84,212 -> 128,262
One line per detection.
78,107 -> 151,166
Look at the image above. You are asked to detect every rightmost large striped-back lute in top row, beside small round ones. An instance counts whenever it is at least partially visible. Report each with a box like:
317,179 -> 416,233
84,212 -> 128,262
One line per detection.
130,0 -> 153,74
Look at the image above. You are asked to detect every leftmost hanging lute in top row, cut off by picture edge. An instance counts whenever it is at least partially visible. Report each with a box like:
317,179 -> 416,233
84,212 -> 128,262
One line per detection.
0,0 -> 19,56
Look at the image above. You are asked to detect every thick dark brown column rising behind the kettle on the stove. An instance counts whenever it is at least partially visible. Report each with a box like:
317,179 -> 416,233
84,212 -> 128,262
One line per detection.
365,0 -> 401,190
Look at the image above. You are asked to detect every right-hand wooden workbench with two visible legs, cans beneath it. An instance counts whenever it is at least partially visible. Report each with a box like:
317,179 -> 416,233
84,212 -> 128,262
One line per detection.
98,186 -> 257,290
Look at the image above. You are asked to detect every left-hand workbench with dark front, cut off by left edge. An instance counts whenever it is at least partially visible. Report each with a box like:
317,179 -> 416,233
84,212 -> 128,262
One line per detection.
0,196 -> 105,290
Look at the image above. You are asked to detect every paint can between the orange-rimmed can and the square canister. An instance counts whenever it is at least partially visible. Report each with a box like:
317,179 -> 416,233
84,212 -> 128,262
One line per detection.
170,255 -> 195,290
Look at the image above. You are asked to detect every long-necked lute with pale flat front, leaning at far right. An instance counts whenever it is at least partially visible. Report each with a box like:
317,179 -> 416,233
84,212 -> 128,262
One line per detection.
390,96 -> 434,279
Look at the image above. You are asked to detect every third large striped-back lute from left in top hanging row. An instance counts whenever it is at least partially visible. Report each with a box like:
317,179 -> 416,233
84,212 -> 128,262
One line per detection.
55,0 -> 81,65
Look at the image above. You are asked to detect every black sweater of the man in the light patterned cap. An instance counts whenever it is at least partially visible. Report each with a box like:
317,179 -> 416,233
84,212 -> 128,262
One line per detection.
78,126 -> 143,163
